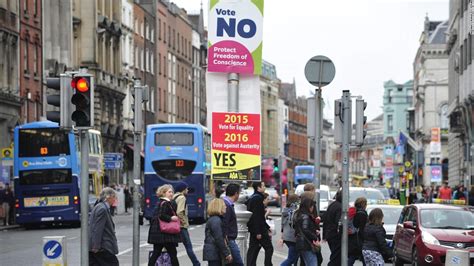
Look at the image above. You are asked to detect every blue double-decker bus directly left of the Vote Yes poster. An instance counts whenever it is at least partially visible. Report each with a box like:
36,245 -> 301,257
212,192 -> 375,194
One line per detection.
144,124 -> 211,221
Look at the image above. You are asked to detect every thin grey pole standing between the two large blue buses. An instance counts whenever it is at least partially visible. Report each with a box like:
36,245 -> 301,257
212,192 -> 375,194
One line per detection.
130,80 -> 143,266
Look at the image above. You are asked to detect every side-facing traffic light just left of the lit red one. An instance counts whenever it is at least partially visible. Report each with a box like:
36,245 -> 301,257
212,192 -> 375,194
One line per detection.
46,74 -> 72,128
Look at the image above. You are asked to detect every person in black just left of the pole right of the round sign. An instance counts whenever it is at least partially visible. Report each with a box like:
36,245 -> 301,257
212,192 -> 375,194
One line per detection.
322,189 -> 342,266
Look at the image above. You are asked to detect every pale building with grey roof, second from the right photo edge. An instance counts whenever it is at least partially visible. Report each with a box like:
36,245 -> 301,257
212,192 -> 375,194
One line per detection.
413,17 -> 449,185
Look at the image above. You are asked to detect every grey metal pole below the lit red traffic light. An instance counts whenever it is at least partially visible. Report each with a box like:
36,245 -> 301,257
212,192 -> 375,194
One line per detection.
79,129 -> 89,266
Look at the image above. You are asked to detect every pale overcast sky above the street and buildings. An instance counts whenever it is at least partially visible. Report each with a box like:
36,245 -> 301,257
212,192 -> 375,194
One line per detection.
172,0 -> 449,121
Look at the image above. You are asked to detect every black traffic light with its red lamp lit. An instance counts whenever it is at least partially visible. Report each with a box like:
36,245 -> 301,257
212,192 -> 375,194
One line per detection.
71,73 -> 94,128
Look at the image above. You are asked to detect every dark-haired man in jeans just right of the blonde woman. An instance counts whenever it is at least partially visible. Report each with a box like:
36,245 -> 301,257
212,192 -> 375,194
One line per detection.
222,183 -> 244,266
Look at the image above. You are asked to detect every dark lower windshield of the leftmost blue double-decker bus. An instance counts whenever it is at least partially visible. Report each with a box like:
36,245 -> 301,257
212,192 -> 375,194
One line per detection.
20,169 -> 72,185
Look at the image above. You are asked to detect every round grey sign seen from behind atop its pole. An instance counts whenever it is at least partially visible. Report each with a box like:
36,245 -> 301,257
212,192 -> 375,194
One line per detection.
304,55 -> 336,88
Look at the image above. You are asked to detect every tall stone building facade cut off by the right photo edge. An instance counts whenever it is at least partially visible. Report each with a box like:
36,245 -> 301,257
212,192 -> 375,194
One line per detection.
447,0 -> 474,188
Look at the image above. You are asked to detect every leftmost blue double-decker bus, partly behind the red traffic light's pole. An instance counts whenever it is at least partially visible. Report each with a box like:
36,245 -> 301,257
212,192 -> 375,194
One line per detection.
13,121 -> 104,225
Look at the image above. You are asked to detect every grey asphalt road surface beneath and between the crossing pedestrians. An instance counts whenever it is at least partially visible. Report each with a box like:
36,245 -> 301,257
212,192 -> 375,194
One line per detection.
0,208 -> 406,265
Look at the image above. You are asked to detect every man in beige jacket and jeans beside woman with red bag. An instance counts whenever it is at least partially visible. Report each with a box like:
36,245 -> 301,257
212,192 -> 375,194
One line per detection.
173,181 -> 201,266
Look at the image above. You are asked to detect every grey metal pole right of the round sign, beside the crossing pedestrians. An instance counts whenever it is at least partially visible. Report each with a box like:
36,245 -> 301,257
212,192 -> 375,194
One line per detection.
341,90 -> 352,265
